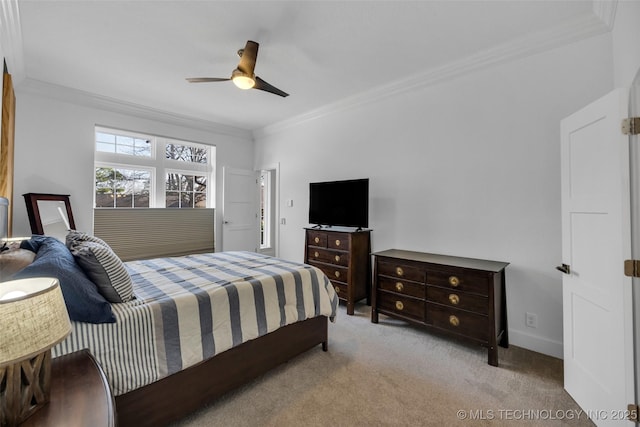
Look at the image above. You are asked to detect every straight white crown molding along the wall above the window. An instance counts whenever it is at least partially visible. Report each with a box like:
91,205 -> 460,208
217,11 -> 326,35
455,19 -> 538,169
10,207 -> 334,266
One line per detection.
15,78 -> 252,140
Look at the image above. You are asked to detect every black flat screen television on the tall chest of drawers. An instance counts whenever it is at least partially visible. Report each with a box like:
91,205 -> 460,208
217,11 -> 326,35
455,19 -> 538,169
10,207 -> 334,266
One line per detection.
309,178 -> 369,228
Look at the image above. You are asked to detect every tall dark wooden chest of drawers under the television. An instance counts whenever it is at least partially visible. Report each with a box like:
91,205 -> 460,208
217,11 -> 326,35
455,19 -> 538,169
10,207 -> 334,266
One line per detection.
304,228 -> 371,315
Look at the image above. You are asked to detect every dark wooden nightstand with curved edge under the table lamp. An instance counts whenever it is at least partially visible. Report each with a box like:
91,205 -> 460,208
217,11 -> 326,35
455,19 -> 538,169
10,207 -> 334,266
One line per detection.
20,350 -> 116,427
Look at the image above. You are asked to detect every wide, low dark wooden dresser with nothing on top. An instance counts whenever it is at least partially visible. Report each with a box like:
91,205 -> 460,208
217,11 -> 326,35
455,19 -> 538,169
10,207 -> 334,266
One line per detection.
371,249 -> 509,366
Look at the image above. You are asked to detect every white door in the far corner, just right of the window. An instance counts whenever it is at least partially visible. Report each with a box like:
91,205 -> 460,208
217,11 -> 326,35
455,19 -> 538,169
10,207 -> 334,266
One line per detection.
222,166 -> 260,252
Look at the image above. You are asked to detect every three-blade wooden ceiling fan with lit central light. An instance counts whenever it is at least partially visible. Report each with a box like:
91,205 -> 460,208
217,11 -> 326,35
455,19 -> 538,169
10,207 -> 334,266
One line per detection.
187,40 -> 289,97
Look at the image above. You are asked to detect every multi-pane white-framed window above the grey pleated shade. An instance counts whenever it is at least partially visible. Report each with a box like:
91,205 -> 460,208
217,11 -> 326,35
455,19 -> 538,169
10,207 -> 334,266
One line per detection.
94,127 -> 215,209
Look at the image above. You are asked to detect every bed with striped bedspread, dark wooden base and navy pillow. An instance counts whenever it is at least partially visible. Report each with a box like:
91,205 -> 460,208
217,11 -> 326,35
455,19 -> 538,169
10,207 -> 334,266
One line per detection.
7,235 -> 338,426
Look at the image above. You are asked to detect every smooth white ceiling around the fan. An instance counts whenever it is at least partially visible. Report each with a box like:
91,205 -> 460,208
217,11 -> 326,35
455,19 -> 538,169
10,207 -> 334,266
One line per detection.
9,0 -> 608,130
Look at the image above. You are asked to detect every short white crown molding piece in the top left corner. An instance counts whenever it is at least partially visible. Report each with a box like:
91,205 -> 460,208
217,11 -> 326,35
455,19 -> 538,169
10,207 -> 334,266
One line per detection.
0,0 -> 27,82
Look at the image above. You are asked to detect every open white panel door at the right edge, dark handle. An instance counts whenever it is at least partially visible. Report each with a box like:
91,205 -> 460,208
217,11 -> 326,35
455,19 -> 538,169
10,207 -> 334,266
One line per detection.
561,90 -> 635,426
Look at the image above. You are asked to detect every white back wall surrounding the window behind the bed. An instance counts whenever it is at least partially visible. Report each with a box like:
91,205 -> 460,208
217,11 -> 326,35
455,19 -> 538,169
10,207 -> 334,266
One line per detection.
13,87 -> 254,248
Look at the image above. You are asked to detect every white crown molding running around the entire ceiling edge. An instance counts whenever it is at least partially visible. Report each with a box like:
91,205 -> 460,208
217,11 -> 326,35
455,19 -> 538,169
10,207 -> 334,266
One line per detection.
0,0 -> 618,139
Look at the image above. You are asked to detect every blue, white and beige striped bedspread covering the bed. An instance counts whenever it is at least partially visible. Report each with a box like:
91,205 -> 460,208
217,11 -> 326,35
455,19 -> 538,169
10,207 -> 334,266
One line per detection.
53,252 -> 338,396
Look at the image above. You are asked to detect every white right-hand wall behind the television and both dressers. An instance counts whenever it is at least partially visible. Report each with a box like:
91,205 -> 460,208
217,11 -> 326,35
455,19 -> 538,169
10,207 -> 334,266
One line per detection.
256,34 -> 613,357
